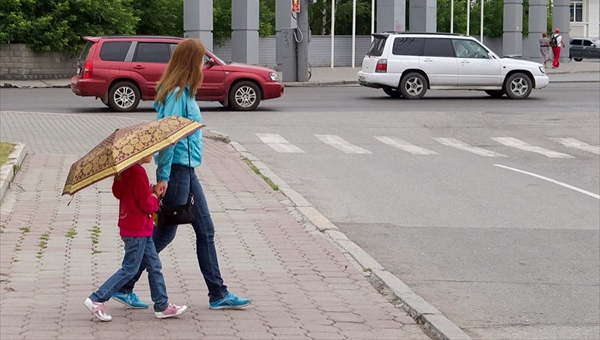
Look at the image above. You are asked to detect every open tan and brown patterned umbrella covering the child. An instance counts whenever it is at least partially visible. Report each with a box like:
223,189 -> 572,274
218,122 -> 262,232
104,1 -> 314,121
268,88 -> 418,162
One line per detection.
62,116 -> 204,195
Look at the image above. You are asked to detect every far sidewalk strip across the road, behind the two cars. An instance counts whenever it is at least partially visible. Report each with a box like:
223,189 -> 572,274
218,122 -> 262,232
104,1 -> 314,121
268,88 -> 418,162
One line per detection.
0,60 -> 600,88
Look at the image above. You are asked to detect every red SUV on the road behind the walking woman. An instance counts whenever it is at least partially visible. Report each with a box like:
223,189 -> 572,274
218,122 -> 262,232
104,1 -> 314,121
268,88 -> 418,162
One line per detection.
71,36 -> 283,112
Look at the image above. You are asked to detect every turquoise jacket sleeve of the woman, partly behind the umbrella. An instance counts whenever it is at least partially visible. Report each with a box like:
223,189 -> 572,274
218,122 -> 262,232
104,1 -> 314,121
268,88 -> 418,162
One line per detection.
154,89 -> 185,182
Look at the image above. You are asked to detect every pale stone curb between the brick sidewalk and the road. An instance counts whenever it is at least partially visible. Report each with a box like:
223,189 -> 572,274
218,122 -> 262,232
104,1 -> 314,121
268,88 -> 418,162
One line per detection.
211,127 -> 471,340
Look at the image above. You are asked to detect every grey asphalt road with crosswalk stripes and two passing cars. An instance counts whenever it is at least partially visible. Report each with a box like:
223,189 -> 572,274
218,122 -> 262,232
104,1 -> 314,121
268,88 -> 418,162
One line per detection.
0,82 -> 600,339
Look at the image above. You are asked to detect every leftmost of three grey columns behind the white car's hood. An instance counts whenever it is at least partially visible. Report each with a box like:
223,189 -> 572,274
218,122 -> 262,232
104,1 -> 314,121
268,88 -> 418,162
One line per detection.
502,0 -> 523,56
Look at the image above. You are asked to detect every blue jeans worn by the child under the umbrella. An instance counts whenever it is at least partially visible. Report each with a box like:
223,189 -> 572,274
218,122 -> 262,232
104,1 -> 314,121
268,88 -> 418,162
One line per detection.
90,236 -> 169,312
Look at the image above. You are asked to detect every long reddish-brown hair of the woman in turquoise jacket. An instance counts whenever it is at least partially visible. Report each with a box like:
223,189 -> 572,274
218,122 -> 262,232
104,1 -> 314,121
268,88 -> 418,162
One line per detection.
154,39 -> 206,105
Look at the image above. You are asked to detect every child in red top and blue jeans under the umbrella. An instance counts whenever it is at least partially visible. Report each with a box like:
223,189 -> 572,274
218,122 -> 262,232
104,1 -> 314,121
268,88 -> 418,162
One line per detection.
84,155 -> 187,321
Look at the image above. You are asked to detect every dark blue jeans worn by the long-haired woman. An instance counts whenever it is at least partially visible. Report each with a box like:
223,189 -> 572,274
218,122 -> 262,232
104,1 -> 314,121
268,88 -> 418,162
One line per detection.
119,164 -> 228,302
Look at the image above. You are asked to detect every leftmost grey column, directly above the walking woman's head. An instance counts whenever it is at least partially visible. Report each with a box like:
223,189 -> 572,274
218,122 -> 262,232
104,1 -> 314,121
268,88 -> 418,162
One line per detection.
183,0 -> 213,51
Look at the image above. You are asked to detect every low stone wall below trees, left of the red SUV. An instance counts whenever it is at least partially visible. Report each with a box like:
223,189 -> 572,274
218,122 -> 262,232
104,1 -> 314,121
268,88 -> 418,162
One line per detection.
0,44 -> 77,80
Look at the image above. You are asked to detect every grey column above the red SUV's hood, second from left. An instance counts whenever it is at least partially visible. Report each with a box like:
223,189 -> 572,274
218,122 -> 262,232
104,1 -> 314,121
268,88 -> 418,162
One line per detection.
231,0 -> 260,65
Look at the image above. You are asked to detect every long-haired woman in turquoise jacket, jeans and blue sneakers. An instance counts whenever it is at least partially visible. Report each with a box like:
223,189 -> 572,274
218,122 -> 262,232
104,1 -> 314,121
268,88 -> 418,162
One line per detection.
113,39 -> 250,309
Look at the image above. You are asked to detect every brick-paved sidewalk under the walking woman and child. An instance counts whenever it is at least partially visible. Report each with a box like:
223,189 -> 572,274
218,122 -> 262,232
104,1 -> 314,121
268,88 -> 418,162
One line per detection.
0,113 -> 428,339
